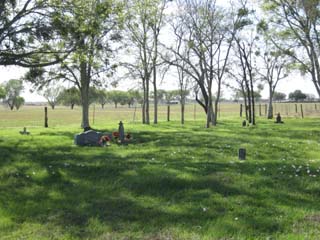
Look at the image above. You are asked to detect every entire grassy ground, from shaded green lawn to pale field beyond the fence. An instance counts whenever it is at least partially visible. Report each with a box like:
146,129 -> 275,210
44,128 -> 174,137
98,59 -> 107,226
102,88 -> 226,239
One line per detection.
0,105 -> 320,240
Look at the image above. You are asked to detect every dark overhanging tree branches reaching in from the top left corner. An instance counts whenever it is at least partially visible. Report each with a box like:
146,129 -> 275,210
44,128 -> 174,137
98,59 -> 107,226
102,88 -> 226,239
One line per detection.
0,0 -> 69,67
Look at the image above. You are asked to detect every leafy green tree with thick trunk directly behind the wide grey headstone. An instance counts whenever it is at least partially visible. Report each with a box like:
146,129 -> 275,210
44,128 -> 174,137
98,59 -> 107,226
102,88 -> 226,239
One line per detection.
26,0 -> 121,129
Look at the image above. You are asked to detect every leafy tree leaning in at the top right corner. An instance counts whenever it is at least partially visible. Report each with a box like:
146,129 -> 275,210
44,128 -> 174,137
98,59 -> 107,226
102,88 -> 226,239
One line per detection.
261,0 -> 320,96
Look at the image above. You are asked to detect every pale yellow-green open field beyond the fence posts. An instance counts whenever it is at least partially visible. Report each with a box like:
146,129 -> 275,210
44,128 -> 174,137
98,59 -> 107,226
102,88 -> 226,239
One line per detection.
0,103 -> 320,127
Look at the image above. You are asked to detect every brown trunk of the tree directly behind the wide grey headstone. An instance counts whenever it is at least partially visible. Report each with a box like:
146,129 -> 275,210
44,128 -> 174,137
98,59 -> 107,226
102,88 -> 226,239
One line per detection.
80,62 -> 90,129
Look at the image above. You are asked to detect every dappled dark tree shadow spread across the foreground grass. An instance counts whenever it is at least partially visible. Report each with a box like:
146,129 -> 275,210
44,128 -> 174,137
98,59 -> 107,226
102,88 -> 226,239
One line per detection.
0,126 -> 320,239
